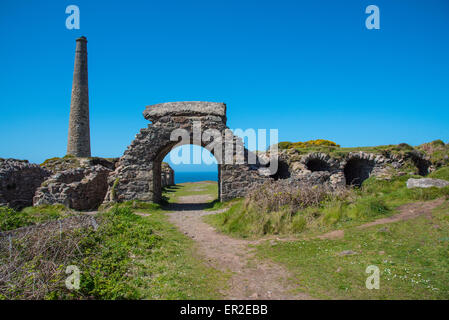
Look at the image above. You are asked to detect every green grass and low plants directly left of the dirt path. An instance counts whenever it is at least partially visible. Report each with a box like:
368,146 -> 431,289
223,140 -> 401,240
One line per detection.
71,207 -> 228,299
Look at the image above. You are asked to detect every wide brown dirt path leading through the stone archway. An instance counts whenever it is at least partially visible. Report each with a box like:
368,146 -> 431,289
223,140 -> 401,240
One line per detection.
167,195 -> 311,300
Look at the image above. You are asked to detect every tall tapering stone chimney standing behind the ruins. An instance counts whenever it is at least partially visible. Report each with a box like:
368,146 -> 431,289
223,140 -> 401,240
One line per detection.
67,37 -> 90,157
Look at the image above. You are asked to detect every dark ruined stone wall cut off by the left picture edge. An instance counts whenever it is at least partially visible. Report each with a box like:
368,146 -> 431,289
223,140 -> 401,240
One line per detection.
0,159 -> 51,209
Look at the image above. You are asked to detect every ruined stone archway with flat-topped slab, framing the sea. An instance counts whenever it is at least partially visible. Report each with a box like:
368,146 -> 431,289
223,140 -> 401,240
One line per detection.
105,101 -> 269,202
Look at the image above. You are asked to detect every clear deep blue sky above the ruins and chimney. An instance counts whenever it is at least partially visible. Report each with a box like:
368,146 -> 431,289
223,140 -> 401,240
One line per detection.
0,0 -> 449,172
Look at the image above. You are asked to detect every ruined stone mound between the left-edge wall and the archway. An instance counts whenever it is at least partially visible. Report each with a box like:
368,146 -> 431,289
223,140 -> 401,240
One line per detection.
33,165 -> 111,210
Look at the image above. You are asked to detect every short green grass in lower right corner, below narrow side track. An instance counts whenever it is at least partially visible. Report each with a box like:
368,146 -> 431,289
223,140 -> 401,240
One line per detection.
257,201 -> 449,299
